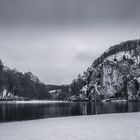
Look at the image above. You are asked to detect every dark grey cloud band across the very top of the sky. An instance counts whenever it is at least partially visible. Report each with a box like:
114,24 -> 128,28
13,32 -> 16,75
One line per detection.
0,0 -> 140,24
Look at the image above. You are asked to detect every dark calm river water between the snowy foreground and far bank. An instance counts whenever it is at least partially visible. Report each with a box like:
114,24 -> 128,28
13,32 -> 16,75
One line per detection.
0,102 -> 140,122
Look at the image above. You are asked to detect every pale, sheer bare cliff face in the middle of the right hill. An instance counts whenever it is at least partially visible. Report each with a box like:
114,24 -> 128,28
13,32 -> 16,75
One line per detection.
102,59 -> 133,96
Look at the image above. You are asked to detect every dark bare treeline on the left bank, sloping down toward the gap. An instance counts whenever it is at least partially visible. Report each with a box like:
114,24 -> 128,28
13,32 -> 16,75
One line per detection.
0,60 -> 51,99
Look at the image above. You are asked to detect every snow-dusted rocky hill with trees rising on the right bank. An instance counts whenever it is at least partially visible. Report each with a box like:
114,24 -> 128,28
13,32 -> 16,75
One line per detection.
71,40 -> 140,100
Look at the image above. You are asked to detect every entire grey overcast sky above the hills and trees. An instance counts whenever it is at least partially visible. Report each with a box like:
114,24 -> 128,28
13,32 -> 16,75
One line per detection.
0,0 -> 140,84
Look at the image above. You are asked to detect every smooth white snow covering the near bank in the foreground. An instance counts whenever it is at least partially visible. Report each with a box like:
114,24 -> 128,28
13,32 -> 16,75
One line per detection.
0,113 -> 140,140
